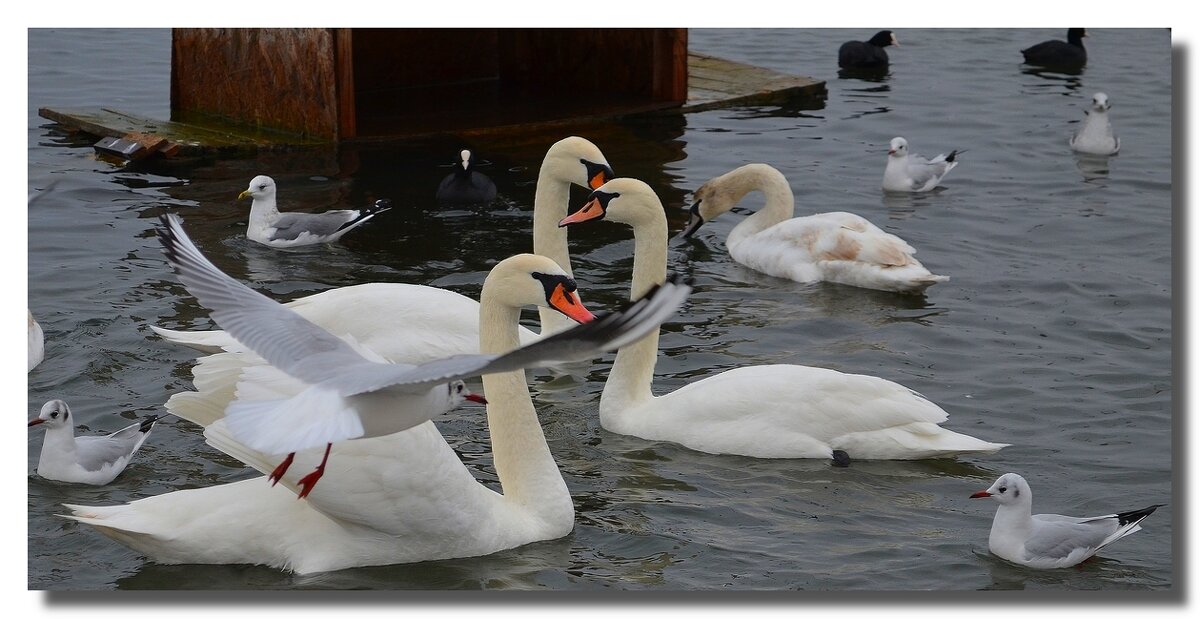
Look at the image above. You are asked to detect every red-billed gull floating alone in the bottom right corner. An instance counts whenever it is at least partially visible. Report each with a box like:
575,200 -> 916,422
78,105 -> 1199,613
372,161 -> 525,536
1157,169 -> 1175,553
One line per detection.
971,473 -> 1162,570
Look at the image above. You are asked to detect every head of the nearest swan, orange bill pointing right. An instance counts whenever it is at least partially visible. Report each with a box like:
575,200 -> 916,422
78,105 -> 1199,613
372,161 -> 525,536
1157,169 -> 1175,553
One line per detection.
480,253 -> 595,323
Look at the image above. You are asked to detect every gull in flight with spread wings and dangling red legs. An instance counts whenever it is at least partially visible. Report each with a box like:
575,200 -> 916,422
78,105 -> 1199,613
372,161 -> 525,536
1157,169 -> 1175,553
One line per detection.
158,216 -> 690,498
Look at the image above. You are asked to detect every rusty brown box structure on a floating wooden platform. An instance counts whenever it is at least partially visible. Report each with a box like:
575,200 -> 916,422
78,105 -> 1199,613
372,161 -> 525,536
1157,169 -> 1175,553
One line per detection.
40,29 -> 826,158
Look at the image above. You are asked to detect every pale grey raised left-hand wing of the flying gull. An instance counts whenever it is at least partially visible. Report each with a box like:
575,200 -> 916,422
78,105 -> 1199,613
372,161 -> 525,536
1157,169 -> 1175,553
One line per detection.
158,215 -> 388,384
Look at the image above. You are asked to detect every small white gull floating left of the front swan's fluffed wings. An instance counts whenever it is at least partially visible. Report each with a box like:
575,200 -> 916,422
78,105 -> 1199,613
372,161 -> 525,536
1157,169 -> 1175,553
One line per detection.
29,399 -> 161,486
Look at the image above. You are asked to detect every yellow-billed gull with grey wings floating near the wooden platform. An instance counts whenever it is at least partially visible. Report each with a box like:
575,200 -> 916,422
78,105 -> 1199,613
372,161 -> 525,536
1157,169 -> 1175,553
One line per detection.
238,175 -> 391,247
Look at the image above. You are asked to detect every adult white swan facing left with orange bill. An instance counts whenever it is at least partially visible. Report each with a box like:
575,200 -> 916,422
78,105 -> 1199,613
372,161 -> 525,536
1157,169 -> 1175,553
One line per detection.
563,179 -> 1007,459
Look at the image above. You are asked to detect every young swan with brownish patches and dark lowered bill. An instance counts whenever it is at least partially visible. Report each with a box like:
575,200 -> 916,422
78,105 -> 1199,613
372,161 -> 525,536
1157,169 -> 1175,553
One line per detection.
683,163 -> 949,293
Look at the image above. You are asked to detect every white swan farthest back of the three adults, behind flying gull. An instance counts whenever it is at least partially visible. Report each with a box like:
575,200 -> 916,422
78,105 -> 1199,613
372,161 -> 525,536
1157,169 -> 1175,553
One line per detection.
151,137 -> 613,357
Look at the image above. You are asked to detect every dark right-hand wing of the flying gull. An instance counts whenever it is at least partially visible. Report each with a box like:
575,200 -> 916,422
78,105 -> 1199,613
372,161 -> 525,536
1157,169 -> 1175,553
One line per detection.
330,278 -> 691,396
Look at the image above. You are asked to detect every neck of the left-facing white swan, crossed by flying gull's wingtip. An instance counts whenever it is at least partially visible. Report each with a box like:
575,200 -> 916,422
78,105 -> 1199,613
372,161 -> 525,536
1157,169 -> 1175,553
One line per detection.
600,211 -> 667,419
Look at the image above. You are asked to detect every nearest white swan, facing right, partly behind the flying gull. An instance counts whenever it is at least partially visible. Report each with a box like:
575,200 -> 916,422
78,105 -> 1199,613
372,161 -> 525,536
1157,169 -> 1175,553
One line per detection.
67,254 -> 688,573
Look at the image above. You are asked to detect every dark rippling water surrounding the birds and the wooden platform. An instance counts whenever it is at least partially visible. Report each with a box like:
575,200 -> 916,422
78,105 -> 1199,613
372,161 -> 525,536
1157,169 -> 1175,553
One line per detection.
28,29 -> 1176,590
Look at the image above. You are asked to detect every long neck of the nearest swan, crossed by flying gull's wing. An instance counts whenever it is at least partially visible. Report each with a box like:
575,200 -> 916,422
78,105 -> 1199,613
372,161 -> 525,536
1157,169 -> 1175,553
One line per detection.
479,292 -> 574,522
